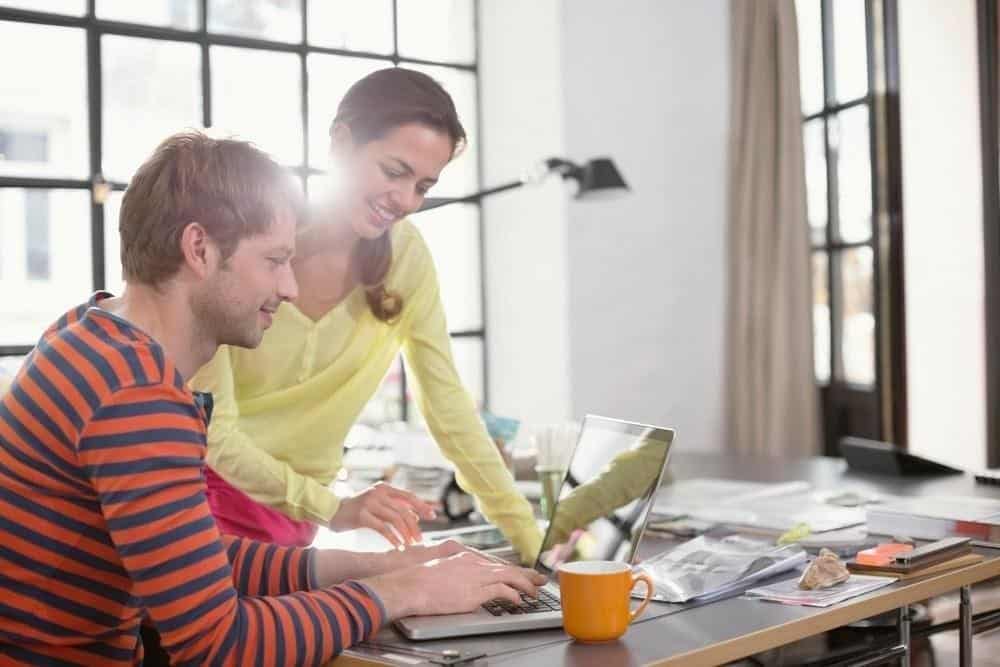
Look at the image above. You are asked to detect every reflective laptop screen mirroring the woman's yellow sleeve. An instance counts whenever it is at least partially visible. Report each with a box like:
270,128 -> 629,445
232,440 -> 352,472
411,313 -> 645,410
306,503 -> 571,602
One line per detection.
535,415 -> 674,574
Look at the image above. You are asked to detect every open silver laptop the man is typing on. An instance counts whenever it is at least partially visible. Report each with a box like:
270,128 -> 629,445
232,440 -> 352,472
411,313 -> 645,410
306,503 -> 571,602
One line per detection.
396,415 -> 674,640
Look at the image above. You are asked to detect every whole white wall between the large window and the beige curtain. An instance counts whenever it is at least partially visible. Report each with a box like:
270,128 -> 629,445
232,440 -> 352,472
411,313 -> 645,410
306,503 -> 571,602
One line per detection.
480,0 -> 729,448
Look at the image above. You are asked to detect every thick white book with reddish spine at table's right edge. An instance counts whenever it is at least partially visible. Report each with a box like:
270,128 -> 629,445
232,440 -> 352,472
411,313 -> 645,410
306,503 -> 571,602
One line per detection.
866,496 -> 1000,542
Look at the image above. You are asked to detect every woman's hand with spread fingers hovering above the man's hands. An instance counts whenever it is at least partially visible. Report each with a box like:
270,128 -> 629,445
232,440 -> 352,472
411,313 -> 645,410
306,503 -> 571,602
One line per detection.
330,482 -> 436,547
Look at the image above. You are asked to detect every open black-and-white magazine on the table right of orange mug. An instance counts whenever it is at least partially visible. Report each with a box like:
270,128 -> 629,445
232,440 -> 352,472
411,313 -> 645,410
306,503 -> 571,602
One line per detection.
636,535 -> 806,602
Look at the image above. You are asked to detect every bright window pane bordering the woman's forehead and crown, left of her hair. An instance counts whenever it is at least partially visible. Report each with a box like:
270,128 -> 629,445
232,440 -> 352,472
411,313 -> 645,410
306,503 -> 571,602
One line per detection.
306,54 -> 392,169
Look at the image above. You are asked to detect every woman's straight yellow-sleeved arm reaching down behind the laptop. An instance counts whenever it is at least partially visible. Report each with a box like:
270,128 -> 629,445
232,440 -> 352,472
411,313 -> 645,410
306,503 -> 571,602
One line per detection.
403,241 -> 542,562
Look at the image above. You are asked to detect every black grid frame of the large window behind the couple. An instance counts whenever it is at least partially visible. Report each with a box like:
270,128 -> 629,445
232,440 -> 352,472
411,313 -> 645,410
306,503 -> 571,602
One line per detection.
0,0 -> 489,421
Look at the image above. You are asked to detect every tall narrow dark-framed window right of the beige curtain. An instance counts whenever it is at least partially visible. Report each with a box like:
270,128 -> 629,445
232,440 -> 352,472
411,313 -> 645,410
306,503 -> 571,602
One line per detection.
796,0 -> 905,454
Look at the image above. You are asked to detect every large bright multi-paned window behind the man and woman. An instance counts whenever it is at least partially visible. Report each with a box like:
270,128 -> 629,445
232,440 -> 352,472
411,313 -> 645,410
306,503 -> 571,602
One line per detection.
0,0 -> 486,422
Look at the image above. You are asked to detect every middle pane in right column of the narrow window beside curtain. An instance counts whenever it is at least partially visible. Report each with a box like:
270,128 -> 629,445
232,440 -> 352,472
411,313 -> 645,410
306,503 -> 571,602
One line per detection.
830,105 -> 872,242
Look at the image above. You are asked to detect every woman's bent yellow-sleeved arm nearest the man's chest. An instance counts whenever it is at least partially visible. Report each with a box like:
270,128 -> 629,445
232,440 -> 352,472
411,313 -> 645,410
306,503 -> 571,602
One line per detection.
191,345 -> 340,525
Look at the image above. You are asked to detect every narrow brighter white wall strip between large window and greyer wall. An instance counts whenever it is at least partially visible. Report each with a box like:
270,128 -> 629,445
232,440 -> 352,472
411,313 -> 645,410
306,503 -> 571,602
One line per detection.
479,0 -> 571,423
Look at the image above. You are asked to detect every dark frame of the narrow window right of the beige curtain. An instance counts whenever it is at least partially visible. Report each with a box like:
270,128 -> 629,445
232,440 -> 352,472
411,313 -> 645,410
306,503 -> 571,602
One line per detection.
802,0 -> 907,456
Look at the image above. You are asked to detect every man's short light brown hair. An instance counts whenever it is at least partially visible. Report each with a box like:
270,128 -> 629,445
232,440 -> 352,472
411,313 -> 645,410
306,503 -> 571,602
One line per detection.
118,131 -> 302,285
